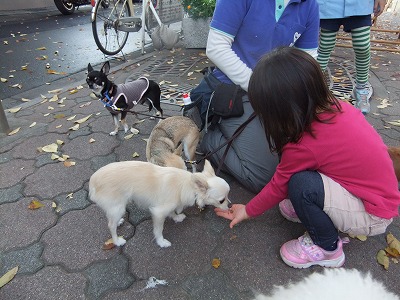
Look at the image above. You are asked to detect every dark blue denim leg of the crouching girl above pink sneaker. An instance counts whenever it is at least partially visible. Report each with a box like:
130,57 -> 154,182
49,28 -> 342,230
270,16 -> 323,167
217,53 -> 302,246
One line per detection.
288,171 -> 339,251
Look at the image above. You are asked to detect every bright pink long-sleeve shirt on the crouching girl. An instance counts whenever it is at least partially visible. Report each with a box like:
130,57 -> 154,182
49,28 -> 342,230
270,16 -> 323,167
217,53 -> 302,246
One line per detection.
246,102 -> 400,219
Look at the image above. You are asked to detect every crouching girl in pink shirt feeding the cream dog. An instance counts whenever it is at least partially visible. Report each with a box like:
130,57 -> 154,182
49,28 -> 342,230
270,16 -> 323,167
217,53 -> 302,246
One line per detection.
215,47 -> 400,268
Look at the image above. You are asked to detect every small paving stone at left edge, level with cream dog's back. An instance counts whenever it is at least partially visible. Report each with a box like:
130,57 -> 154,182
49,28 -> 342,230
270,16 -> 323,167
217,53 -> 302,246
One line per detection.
0,159 -> 35,188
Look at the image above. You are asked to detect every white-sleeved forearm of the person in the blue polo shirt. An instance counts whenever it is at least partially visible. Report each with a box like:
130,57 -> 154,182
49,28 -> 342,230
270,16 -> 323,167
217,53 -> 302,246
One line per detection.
206,28 -> 252,91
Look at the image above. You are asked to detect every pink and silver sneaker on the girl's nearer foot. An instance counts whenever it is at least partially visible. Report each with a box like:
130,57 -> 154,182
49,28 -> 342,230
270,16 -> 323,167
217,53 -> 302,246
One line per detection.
280,232 -> 345,268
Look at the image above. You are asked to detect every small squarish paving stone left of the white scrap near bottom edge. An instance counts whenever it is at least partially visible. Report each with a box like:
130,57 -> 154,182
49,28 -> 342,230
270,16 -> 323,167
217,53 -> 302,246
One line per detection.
85,255 -> 135,299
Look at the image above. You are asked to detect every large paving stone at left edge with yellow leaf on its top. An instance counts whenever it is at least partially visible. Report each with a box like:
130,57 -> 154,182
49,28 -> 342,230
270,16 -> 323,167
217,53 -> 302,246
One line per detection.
0,198 -> 57,251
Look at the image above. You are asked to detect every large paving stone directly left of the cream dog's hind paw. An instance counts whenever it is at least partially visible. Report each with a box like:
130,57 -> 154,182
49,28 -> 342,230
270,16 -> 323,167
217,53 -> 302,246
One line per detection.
41,205 -> 129,270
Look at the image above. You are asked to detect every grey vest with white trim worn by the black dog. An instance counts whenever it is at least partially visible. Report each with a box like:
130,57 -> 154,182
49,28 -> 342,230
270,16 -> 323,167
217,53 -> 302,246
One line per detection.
101,77 -> 149,112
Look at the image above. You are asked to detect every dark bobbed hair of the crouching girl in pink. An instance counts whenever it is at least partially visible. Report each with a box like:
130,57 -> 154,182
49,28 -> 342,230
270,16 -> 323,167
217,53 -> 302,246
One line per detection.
248,47 -> 341,153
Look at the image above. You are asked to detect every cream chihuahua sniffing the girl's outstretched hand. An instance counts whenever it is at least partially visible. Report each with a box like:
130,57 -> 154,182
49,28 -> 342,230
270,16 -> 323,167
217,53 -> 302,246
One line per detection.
89,160 -> 230,247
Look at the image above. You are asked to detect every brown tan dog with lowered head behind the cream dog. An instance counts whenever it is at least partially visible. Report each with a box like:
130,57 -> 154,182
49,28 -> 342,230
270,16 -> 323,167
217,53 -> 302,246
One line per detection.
146,116 -> 200,172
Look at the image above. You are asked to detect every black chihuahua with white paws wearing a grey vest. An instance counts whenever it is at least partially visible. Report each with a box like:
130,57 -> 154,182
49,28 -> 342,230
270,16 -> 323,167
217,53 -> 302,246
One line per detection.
86,61 -> 163,135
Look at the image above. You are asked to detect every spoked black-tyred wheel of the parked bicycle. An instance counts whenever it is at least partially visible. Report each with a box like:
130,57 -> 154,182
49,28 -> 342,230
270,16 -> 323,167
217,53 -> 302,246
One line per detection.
92,0 -> 131,55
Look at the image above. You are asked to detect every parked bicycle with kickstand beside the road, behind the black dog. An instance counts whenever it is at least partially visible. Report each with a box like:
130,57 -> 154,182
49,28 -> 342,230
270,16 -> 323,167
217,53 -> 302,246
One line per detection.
91,0 -> 161,55
